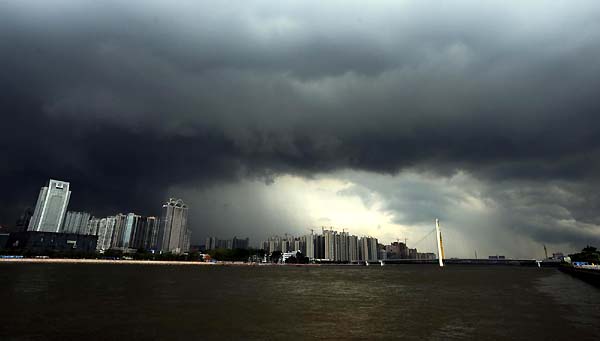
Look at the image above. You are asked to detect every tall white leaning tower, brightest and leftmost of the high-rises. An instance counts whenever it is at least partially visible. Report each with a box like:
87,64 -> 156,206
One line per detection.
28,179 -> 71,232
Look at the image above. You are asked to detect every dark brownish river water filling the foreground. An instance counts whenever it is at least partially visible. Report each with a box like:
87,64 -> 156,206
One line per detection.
0,264 -> 600,340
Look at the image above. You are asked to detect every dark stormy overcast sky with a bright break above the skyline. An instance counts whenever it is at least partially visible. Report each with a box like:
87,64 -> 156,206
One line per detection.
0,0 -> 600,258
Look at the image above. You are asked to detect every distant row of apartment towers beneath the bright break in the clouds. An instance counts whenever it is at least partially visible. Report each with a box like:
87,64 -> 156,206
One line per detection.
262,228 -> 380,262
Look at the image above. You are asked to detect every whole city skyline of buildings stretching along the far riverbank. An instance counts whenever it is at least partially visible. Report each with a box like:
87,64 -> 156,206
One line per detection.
2,175 -> 576,262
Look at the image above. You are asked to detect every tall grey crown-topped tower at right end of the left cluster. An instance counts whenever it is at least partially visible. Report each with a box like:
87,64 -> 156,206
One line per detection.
158,198 -> 191,253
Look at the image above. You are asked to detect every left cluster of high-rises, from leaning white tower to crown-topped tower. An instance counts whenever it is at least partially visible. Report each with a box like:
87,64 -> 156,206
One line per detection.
21,180 -> 191,253
